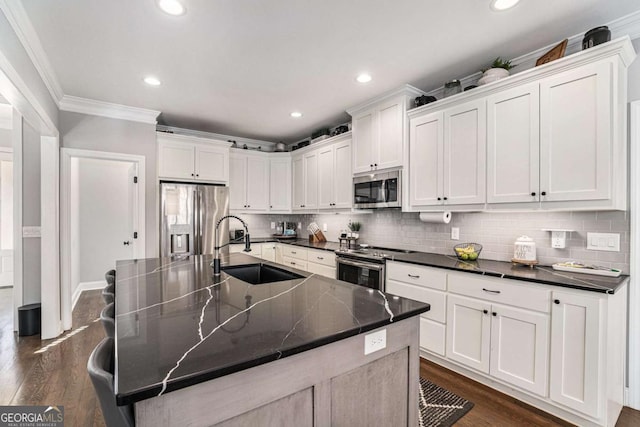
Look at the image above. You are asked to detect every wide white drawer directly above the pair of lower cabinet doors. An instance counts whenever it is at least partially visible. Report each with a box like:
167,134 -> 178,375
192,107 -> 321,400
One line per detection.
449,273 -> 551,313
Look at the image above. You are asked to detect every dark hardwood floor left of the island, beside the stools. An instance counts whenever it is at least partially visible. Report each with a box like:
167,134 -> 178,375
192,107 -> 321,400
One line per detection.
0,289 -> 105,427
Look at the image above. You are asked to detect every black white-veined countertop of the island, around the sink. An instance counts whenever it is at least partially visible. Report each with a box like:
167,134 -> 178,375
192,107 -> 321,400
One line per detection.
115,253 -> 429,405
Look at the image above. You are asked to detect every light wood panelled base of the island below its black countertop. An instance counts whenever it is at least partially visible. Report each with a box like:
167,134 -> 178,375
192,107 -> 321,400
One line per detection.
135,316 -> 420,427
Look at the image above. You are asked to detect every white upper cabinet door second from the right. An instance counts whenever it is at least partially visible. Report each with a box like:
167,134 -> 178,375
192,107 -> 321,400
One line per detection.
487,83 -> 540,203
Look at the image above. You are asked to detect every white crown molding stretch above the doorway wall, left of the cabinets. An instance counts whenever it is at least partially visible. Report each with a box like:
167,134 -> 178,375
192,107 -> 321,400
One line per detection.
60,95 -> 160,125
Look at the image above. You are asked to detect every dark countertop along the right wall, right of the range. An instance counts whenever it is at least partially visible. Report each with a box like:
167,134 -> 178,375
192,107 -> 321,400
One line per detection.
388,252 -> 629,294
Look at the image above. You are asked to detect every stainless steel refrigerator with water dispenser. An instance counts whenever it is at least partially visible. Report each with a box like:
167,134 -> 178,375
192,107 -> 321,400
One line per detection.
160,182 -> 229,257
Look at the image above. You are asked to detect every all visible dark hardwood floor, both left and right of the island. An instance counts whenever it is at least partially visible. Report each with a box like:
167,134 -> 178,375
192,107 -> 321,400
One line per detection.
0,289 -> 640,427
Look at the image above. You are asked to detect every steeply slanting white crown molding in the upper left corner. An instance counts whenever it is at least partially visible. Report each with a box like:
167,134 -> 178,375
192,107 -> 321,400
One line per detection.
0,0 -> 64,107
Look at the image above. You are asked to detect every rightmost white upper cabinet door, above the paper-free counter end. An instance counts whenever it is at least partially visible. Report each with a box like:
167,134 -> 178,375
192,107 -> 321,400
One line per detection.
540,61 -> 613,202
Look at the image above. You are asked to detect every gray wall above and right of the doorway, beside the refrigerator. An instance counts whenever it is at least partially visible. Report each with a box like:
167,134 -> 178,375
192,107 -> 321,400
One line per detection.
60,111 -> 158,257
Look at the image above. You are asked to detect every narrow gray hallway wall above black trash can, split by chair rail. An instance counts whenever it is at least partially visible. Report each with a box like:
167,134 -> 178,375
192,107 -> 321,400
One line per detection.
22,118 -> 41,304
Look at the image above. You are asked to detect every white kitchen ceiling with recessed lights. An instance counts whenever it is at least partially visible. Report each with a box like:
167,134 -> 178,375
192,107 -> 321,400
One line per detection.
22,0 -> 640,143
